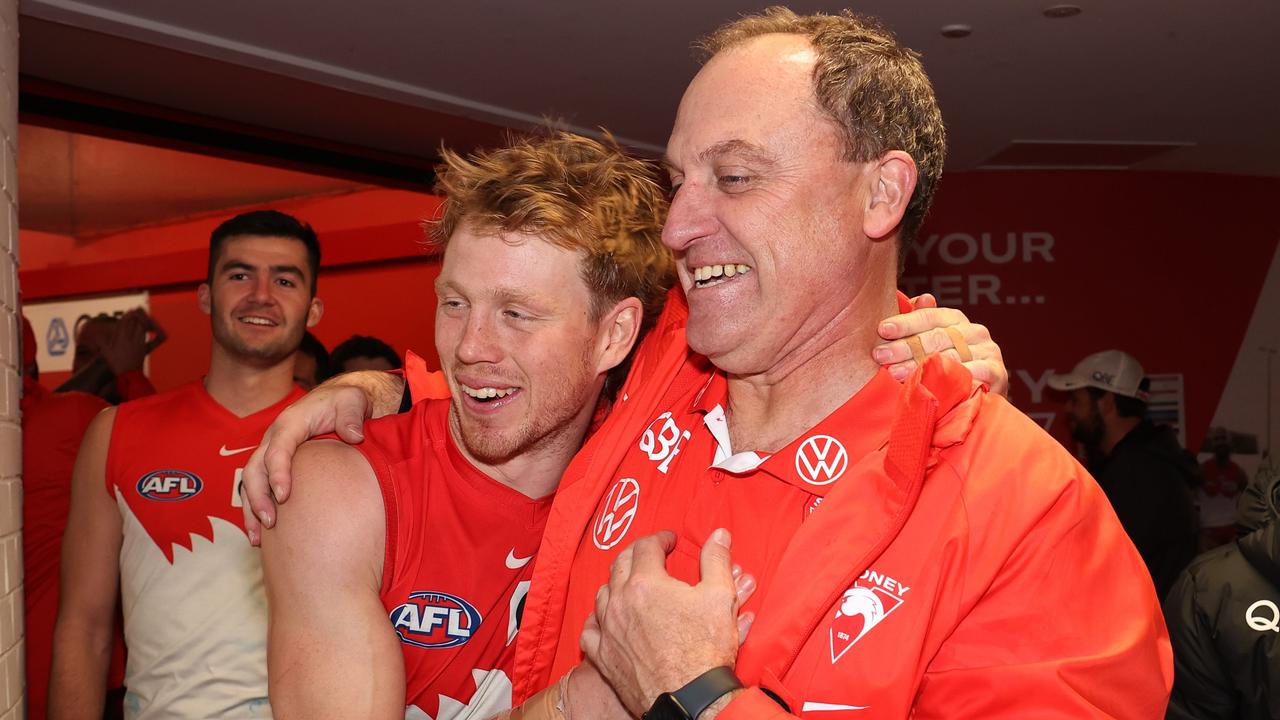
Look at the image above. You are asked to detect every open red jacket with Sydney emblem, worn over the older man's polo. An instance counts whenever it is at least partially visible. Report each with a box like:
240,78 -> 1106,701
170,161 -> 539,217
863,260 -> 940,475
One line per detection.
515,289 -> 1172,720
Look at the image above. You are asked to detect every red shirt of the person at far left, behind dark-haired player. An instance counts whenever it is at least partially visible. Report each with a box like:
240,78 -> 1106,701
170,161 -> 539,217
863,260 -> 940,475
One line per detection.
22,376 -> 117,717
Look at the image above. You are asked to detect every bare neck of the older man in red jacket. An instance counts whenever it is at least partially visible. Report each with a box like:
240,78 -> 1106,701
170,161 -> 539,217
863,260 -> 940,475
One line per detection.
727,288 -> 897,452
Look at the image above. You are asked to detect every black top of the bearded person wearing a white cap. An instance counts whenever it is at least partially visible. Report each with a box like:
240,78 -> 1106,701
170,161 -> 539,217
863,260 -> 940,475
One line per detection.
1091,420 -> 1201,598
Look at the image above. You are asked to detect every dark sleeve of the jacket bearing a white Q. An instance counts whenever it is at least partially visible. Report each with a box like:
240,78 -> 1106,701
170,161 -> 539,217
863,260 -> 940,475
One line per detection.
1165,570 -> 1236,720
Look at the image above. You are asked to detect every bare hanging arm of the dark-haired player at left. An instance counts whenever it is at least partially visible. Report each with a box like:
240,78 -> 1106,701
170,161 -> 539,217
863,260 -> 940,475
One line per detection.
49,407 -> 122,719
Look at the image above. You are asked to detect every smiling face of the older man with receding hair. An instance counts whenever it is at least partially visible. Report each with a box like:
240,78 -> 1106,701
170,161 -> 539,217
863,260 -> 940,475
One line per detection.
663,35 -> 896,374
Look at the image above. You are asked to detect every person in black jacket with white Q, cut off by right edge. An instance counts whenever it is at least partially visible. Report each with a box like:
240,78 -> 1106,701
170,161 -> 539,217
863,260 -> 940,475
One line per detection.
1165,461 -> 1280,720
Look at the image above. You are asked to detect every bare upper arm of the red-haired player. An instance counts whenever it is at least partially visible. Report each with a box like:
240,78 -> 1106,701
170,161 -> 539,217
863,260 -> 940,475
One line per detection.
262,441 -> 404,720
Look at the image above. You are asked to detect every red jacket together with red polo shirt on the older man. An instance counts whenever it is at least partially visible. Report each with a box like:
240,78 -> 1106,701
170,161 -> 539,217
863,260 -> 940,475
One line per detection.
515,289 -> 1172,720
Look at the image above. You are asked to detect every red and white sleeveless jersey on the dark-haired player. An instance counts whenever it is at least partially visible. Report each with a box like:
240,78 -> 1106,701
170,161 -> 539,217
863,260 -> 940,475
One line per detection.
106,380 -> 303,720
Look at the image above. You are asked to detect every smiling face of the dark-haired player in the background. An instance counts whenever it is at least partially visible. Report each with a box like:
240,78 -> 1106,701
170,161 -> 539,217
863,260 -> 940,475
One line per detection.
198,236 -> 323,366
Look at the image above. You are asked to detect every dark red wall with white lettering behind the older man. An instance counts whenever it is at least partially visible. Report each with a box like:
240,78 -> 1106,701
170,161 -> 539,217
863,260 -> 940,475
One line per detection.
901,172 -> 1280,448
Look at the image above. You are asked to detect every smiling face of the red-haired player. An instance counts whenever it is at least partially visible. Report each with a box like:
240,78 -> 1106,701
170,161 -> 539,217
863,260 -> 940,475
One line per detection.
435,223 -> 627,464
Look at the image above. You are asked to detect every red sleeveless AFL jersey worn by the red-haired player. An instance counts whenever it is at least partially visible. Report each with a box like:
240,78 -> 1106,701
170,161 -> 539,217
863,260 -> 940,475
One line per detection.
355,400 -> 550,717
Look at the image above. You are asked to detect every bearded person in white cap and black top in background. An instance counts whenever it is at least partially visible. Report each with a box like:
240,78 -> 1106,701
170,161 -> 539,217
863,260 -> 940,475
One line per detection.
1048,350 -> 1199,597
